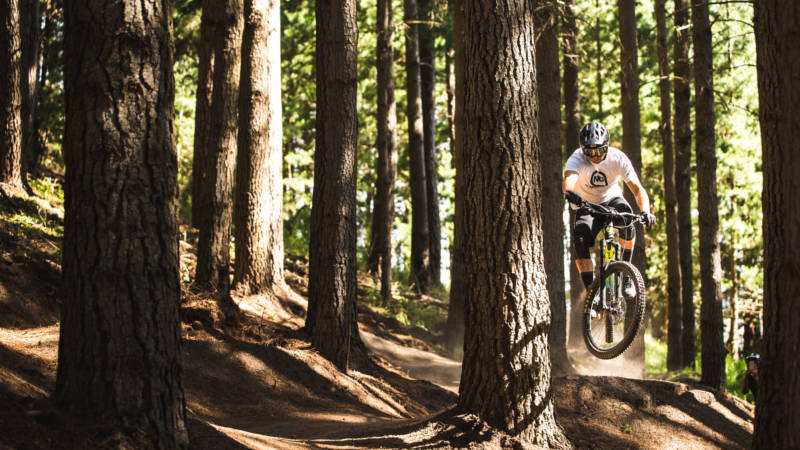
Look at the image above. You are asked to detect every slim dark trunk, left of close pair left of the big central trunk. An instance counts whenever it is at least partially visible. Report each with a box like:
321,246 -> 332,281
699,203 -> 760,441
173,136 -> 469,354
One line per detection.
404,0 -> 431,294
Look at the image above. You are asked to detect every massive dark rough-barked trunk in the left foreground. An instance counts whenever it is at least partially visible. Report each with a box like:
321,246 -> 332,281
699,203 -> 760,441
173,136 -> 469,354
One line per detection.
54,0 -> 188,448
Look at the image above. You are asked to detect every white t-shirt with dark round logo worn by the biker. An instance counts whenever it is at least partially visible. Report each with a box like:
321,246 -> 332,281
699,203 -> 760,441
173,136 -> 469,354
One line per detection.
564,147 -> 639,208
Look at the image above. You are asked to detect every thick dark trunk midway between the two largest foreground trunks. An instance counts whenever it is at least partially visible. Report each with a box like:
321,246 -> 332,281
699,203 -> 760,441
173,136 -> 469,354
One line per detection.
306,0 -> 360,370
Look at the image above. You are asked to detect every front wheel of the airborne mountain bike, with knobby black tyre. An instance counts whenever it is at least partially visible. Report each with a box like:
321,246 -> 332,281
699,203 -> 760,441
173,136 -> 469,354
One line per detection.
583,261 -> 645,359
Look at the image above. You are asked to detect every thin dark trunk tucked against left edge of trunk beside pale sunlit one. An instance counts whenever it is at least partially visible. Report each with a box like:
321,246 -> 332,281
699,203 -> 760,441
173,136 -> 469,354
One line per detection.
192,0 -> 219,228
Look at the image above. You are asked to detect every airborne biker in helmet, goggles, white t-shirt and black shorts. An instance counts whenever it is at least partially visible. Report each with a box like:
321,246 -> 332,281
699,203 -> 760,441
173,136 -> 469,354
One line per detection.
562,122 -> 656,297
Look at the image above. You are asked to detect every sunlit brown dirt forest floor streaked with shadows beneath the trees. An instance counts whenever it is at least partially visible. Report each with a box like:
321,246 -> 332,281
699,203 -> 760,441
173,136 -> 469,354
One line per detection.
0,191 -> 753,449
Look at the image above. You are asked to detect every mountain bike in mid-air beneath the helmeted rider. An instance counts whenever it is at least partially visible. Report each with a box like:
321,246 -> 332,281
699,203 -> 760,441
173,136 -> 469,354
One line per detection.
578,200 -> 645,359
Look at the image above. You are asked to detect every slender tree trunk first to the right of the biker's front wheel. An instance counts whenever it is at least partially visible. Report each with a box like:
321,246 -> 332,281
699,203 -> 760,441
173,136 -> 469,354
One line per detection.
656,0 -> 682,370
